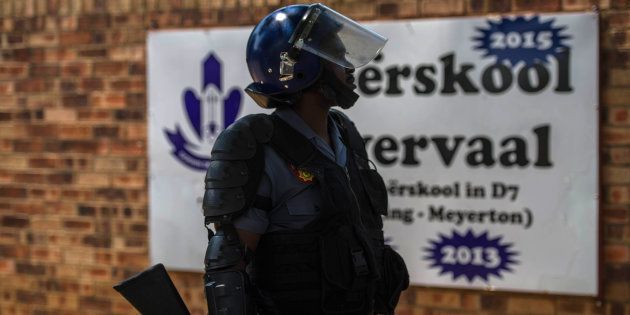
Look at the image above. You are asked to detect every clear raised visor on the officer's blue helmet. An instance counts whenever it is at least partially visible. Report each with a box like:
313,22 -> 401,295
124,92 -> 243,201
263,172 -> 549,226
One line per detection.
289,3 -> 387,69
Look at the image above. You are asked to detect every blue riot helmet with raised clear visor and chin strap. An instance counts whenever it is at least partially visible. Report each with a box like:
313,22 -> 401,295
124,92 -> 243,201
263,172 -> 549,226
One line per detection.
245,3 -> 387,108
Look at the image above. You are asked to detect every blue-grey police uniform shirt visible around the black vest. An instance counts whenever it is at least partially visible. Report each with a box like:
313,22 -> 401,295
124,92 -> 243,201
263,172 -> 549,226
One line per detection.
234,108 -> 346,234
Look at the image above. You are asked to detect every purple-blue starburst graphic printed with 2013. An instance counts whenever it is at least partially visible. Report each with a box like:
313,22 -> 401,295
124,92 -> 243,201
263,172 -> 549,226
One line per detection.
423,230 -> 518,283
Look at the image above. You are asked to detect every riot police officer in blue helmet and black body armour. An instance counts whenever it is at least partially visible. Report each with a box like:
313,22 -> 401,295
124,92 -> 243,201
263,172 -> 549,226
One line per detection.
203,4 -> 408,315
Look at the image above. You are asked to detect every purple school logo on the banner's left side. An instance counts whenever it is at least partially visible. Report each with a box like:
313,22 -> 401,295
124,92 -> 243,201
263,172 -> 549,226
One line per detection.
164,52 -> 242,171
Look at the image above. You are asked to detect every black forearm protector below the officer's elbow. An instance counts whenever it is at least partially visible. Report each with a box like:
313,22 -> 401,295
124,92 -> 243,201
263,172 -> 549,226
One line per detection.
204,221 -> 256,315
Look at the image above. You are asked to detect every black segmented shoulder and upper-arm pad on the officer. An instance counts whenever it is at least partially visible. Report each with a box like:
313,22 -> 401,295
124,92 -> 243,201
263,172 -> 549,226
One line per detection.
203,114 -> 273,220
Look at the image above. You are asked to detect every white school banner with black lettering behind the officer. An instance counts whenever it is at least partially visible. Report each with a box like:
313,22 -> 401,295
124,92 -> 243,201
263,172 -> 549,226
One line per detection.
148,14 -> 598,295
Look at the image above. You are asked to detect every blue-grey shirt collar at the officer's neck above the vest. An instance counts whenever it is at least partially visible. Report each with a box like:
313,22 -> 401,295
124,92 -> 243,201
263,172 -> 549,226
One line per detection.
275,108 -> 346,167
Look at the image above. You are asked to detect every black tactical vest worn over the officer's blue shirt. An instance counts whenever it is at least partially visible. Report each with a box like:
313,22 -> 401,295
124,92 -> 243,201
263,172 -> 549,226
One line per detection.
251,111 -> 387,315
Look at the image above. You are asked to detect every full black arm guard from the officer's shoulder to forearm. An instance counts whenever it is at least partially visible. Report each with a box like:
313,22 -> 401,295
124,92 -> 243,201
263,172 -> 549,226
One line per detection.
203,114 -> 273,315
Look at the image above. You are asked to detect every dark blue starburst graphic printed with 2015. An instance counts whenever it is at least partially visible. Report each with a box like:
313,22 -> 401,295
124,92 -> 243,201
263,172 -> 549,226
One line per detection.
472,16 -> 571,67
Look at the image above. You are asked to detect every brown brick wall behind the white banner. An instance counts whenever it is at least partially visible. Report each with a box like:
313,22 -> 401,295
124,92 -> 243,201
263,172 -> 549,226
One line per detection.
0,0 -> 630,315
